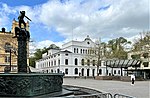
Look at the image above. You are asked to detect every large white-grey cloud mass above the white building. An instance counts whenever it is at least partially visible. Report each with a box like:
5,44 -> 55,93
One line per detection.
32,0 -> 149,39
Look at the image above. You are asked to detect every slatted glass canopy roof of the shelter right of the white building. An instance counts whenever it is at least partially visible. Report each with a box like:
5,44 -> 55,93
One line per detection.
105,59 -> 141,68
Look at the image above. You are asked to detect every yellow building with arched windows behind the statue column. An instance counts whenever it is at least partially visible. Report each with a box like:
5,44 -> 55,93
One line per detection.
0,19 -> 29,72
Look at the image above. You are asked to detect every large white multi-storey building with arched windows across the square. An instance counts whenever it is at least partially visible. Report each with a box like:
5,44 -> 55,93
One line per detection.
36,36 -> 123,76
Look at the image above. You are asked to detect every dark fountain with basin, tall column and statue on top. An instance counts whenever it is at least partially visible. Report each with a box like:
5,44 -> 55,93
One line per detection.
0,11 -> 63,97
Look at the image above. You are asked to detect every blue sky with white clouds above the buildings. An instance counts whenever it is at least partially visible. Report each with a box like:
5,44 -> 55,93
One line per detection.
0,0 -> 150,51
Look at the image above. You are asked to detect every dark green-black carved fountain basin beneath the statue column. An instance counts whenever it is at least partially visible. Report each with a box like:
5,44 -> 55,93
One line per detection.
0,73 -> 63,97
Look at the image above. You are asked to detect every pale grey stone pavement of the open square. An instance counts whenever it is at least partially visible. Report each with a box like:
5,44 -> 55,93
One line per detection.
63,78 -> 150,98
